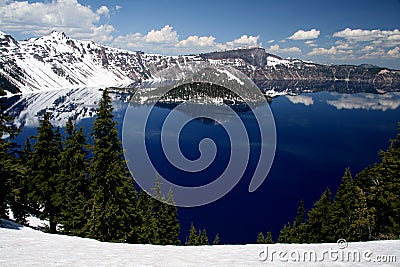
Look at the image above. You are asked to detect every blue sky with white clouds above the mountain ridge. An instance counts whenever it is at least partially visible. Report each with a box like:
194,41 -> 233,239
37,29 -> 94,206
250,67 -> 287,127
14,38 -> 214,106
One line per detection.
0,0 -> 400,69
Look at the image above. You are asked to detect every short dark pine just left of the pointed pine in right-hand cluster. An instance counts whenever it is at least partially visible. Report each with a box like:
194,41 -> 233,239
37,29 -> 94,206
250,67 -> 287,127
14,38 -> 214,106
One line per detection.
305,188 -> 336,243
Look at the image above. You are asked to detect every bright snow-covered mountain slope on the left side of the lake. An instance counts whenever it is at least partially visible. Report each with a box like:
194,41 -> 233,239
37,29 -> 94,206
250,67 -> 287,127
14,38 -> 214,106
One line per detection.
0,31 -> 202,96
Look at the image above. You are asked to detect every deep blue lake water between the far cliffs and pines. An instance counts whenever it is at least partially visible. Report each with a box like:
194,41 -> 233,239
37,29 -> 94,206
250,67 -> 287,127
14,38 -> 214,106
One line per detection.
10,92 -> 400,244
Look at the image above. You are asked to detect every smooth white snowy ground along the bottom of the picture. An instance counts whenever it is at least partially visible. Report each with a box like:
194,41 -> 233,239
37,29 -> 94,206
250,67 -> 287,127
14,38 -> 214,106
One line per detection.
0,220 -> 400,266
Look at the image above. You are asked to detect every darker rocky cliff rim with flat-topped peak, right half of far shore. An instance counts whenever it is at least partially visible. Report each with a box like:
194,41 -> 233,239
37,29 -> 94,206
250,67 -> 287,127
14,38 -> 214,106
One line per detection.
200,48 -> 400,91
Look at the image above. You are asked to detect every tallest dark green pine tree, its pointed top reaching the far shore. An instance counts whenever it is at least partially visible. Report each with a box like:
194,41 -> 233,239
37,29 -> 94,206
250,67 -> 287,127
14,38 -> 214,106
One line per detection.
86,90 -> 137,243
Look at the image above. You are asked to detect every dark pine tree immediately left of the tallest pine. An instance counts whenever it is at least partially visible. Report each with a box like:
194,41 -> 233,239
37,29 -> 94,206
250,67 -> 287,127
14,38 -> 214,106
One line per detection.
59,118 -> 89,236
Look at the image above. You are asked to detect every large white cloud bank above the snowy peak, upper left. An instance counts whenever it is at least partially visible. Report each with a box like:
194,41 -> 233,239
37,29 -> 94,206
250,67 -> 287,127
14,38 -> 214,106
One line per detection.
0,0 -> 114,42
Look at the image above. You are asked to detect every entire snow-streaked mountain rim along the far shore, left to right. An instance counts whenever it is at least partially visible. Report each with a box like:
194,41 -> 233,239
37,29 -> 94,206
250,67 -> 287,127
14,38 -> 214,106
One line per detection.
0,32 -> 400,97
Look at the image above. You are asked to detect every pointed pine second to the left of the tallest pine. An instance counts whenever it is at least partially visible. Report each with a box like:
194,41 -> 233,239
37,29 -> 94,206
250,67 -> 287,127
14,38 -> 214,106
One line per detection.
29,113 -> 62,233
